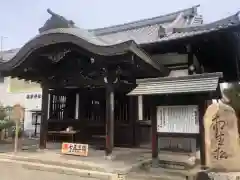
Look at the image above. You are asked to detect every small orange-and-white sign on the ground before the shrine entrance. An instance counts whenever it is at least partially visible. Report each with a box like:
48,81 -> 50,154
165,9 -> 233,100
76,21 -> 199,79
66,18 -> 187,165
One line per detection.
62,143 -> 88,156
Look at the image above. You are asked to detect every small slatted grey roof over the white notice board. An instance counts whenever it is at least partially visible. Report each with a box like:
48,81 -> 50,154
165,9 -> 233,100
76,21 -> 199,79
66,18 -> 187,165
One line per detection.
128,73 -> 222,95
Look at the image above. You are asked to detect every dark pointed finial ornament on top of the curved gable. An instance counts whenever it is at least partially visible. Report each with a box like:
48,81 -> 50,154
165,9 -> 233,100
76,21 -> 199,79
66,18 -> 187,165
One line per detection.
39,9 -> 75,33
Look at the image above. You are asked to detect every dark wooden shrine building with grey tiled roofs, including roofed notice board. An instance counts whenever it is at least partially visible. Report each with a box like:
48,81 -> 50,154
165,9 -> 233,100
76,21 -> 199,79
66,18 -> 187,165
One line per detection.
0,6 -> 240,168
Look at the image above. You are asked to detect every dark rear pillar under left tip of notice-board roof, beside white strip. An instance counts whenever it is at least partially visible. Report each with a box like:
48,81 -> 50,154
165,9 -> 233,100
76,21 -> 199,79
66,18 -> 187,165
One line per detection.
128,96 -> 140,146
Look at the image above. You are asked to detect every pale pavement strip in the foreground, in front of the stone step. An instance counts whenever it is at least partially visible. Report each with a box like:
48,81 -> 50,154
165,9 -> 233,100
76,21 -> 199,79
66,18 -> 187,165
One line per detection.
0,158 -> 186,180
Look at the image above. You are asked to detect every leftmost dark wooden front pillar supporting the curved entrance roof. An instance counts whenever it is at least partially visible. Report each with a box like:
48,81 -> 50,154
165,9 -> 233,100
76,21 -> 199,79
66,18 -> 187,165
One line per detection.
39,83 -> 49,149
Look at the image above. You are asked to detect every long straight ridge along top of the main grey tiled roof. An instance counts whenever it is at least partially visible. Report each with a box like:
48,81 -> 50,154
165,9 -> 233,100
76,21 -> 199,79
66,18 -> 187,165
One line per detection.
89,5 -> 200,35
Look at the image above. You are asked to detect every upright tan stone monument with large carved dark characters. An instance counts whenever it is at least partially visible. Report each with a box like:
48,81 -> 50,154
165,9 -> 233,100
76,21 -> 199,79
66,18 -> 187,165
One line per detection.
204,102 -> 240,171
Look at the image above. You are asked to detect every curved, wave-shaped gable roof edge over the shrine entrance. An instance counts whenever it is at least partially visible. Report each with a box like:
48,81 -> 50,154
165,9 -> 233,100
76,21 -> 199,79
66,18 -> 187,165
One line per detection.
0,28 -> 169,74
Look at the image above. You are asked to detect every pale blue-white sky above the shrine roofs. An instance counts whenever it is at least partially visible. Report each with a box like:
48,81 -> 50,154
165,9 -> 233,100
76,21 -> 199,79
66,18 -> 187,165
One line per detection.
0,0 -> 240,49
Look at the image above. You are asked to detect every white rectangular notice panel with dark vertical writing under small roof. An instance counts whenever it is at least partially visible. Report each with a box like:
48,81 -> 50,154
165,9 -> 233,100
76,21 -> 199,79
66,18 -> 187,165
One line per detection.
157,105 -> 199,134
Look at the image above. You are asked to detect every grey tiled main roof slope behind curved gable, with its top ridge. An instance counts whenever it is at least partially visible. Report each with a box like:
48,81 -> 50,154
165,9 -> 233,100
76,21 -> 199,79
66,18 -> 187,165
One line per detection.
89,6 -> 198,44
